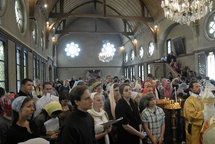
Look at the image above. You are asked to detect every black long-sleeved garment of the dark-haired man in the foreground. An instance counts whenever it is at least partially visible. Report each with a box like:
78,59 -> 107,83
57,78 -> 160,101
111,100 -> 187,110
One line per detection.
60,109 -> 96,144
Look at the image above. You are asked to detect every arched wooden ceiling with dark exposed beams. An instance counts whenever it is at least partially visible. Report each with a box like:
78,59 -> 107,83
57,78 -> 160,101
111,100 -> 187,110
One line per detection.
38,0 -> 163,43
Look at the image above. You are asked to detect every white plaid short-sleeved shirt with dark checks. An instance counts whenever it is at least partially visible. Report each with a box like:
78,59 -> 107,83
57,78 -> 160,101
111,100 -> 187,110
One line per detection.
141,106 -> 165,144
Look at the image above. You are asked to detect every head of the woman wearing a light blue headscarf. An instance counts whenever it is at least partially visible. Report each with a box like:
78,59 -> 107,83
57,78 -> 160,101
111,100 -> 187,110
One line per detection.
12,96 -> 35,124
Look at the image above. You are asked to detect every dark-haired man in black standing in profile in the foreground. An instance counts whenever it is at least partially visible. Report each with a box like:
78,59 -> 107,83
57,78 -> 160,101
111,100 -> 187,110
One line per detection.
60,86 -> 96,144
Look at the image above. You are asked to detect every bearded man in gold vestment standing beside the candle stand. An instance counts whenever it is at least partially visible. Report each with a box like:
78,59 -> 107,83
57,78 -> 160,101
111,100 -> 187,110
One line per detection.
184,81 -> 204,144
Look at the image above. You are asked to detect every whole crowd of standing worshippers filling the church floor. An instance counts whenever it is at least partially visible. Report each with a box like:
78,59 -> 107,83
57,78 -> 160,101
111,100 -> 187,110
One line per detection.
0,74 -> 215,144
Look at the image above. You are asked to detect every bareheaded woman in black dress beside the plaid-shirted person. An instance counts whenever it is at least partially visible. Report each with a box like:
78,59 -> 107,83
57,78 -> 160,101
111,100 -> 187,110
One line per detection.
115,84 -> 144,144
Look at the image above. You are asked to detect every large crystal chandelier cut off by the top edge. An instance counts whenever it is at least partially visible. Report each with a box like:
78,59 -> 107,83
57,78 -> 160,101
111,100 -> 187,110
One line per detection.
161,0 -> 213,25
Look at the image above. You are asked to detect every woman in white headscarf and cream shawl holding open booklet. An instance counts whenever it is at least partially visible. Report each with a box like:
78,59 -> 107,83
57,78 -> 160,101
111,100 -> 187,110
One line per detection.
88,92 -> 111,144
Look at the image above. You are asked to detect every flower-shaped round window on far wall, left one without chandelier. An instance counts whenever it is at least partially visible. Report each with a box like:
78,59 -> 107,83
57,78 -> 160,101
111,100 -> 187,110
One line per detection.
65,42 -> 80,58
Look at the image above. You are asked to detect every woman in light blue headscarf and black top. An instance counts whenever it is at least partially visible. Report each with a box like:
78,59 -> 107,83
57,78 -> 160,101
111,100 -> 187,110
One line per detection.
6,96 -> 39,144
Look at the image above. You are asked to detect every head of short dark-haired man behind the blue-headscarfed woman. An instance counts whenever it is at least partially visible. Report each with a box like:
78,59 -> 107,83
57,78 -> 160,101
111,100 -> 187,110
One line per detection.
21,78 -> 33,94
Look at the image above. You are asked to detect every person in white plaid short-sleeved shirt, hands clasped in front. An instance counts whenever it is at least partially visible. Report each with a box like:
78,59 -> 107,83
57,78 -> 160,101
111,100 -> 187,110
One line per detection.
141,93 -> 165,144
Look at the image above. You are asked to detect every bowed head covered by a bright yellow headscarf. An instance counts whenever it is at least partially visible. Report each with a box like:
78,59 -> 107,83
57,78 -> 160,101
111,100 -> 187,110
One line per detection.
43,101 -> 62,118
